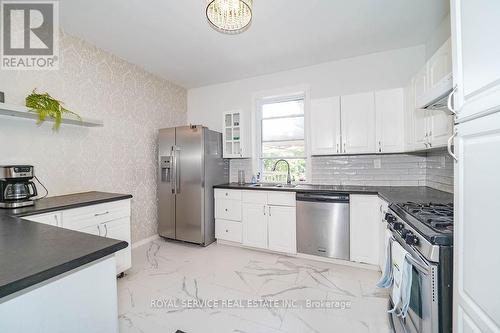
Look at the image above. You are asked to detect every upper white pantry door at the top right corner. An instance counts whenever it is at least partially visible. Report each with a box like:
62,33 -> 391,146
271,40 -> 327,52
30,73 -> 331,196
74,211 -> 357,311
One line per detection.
451,0 -> 500,120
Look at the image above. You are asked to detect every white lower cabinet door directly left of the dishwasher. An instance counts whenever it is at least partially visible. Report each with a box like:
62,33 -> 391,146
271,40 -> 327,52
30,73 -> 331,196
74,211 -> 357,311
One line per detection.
268,206 -> 297,254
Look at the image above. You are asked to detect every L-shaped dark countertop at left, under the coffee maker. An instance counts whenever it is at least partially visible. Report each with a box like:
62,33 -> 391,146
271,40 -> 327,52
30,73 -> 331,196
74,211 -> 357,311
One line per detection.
0,192 -> 132,299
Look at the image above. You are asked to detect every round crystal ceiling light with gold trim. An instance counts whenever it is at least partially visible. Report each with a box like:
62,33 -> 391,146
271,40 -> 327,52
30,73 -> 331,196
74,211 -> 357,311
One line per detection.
206,0 -> 252,34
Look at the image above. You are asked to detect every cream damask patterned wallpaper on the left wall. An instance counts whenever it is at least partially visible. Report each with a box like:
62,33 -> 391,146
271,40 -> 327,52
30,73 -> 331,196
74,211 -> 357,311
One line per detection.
0,33 -> 187,242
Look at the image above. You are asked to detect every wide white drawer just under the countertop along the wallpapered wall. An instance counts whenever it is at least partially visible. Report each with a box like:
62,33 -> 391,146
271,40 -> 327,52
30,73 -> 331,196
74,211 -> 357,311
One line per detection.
63,200 -> 130,230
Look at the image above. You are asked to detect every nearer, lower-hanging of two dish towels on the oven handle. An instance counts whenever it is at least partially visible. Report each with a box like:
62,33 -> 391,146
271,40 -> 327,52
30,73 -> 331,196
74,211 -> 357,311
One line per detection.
389,242 -> 413,318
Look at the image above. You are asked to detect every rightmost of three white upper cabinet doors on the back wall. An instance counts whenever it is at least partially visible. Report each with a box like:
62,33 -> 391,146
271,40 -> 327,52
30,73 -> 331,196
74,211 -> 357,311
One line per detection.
375,88 -> 404,153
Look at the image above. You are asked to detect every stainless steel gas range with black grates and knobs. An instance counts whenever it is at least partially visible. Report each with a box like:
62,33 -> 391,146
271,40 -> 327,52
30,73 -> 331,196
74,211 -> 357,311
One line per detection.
385,202 -> 453,333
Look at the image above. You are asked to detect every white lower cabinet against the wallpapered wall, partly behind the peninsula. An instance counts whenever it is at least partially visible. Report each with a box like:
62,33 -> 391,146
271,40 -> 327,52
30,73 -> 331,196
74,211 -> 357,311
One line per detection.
23,200 -> 132,274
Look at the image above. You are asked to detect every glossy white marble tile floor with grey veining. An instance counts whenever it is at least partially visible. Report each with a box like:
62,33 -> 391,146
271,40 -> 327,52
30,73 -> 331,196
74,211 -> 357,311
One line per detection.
118,240 -> 390,333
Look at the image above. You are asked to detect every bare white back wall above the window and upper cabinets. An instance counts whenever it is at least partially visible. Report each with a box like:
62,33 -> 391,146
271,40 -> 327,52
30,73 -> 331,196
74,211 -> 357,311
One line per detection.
188,45 -> 425,131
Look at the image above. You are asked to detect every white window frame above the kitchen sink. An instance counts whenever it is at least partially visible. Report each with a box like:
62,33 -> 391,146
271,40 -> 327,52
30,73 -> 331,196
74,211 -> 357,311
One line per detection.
255,92 -> 310,182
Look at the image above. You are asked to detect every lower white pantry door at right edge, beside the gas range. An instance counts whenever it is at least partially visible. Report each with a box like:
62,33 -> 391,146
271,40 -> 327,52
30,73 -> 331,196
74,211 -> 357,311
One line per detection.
453,113 -> 500,333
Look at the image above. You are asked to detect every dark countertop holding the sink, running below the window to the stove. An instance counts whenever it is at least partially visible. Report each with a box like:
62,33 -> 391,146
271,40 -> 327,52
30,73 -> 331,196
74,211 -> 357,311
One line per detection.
214,183 -> 453,203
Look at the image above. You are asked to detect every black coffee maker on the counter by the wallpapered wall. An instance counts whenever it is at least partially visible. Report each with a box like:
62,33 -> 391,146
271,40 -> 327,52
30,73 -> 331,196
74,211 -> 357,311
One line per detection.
0,165 -> 38,208
